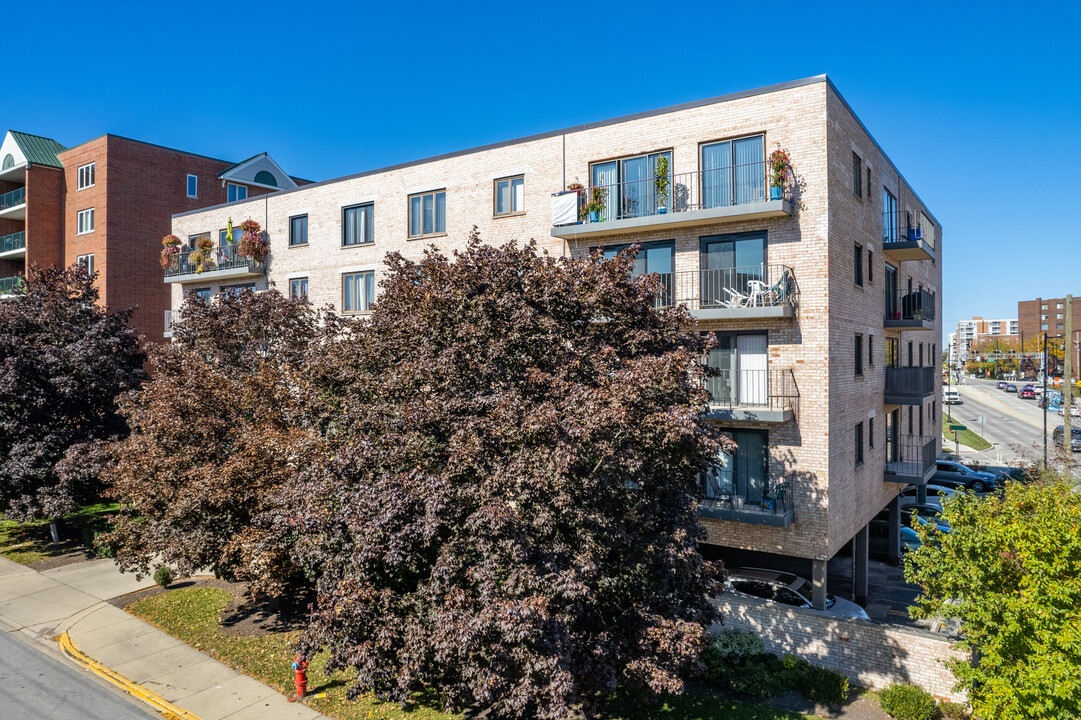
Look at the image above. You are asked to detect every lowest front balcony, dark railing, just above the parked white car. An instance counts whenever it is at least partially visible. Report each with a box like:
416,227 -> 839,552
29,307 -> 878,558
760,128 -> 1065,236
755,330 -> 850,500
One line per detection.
698,469 -> 796,528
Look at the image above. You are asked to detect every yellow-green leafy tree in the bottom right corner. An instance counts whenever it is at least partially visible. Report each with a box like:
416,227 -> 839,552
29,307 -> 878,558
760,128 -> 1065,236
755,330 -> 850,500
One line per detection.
905,479 -> 1081,720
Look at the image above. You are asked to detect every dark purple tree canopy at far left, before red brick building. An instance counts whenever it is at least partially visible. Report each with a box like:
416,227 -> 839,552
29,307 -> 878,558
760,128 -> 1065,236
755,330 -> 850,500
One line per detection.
0,265 -> 146,520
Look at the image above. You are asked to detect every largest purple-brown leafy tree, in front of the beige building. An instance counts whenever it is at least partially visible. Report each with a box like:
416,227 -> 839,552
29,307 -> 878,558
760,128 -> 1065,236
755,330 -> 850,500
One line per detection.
287,236 -> 721,718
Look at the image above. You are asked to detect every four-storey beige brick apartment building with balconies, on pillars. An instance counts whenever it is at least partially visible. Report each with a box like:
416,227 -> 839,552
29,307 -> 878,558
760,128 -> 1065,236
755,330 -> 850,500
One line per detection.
172,76 -> 942,605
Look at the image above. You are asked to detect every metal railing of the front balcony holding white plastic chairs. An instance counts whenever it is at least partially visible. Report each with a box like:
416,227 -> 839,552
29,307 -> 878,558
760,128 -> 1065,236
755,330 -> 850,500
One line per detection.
656,265 -> 799,310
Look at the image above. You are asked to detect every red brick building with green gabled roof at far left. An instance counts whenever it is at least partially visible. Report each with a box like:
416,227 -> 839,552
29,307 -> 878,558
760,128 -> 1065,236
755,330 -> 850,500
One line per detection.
0,131 -> 305,342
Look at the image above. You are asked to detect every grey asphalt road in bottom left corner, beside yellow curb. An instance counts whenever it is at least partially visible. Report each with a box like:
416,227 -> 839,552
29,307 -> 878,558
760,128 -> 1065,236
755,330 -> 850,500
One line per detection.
0,631 -> 154,720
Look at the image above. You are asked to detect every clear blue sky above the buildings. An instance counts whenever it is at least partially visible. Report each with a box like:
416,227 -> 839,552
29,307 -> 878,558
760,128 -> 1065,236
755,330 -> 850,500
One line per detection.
0,0 -> 1081,334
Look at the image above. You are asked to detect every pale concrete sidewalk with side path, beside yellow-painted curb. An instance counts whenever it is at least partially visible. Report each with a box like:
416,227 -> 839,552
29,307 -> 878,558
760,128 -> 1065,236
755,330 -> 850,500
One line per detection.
0,551 -> 323,720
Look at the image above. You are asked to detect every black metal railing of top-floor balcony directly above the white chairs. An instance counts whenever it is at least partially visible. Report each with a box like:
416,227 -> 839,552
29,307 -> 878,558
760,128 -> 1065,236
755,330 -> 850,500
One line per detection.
556,160 -> 787,223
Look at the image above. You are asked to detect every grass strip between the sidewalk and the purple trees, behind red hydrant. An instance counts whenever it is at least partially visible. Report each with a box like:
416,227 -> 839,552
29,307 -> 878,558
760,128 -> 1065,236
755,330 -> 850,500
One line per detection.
128,588 -> 805,720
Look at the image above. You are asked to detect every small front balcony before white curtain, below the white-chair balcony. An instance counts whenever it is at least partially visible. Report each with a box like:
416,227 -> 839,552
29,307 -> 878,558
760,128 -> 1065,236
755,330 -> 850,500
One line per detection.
706,368 -> 800,423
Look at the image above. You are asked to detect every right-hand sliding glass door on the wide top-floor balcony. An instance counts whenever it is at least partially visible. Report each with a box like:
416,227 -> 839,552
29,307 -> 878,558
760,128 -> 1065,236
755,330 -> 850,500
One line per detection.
702,135 -> 765,209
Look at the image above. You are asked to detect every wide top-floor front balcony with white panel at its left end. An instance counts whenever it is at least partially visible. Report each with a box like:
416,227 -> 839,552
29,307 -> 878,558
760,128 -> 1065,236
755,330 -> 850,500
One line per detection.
551,162 -> 792,238
